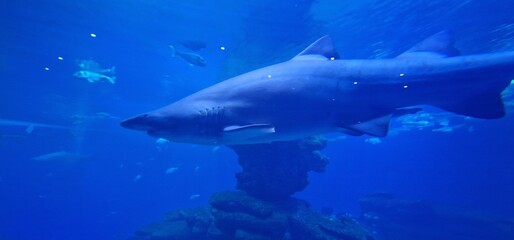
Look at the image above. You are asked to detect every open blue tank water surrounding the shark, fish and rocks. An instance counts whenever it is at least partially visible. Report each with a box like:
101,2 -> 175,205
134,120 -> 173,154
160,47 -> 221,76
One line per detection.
0,0 -> 514,240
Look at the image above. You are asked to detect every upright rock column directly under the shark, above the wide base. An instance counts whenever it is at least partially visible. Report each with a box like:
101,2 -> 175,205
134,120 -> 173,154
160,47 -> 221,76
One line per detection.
231,137 -> 328,200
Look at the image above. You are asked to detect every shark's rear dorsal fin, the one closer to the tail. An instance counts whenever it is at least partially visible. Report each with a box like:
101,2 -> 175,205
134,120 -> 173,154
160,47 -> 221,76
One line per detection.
397,31 -> 459,58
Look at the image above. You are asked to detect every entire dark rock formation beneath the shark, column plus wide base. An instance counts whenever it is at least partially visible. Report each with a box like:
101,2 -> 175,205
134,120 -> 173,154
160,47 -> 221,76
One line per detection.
127,137 -> 373,240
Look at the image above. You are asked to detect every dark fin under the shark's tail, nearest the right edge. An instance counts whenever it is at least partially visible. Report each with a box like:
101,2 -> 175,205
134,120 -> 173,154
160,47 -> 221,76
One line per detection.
437,93 -> 505,119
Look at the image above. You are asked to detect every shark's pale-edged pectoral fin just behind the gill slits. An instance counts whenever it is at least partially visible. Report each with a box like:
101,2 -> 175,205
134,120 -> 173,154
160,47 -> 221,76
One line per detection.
223,124 -> 275,139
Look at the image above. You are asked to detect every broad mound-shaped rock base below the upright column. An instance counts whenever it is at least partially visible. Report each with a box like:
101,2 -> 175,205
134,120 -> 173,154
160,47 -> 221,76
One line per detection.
131,191 -> 373,240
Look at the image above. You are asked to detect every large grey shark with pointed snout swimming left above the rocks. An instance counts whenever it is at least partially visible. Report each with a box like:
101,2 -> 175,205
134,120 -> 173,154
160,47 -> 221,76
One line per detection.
121,32 -> 514,145
